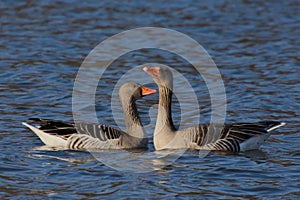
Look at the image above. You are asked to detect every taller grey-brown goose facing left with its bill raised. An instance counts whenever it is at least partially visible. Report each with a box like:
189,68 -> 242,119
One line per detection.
143,66 -> 285,152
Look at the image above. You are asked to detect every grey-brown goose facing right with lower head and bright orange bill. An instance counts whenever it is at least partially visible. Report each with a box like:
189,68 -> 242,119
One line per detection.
23,82 -> 156,150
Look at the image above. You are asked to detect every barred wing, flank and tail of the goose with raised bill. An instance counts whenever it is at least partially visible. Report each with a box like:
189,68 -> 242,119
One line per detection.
191,121 -> 285,152
